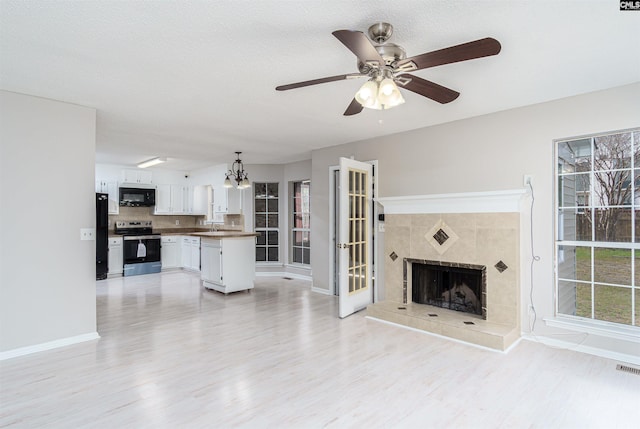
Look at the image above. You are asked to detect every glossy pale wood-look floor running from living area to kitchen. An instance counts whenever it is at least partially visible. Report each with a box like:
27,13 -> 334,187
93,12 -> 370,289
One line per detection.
0,271 -> 640,428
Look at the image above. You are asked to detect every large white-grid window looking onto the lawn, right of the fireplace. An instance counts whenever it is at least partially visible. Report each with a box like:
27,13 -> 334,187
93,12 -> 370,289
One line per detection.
556,129 -> 640,326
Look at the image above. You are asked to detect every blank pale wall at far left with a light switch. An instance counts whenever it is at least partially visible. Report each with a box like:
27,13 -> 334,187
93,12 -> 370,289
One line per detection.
0,91 -> 97,352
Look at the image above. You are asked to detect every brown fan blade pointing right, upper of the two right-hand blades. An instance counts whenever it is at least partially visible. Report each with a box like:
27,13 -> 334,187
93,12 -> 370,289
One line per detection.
397,37 -> 502,71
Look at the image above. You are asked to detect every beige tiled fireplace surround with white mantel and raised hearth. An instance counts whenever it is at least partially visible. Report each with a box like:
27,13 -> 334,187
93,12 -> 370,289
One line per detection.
367,190 -> 524,351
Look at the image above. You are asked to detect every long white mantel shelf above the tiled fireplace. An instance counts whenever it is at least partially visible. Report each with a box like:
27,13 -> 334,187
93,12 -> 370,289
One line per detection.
376,188 -> 529,214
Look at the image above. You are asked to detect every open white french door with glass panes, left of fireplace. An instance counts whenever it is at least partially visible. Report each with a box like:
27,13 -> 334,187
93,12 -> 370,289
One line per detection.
336,158 -> 373,318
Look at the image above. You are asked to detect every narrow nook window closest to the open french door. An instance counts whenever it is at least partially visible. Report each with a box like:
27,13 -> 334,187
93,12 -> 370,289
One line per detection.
291,180 -> 311,265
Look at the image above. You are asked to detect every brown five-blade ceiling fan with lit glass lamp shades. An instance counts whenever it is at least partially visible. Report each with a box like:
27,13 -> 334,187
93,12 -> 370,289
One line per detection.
276,22 -> 501,116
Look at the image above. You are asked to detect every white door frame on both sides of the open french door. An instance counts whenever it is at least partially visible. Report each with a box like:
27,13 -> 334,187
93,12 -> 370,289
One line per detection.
328,159 -> 380,302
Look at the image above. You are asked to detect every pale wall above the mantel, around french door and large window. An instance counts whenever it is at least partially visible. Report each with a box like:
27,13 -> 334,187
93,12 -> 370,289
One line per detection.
311,83 -> 640,358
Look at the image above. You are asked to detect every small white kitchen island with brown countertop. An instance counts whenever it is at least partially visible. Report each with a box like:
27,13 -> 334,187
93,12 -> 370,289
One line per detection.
189,231 -> 258,294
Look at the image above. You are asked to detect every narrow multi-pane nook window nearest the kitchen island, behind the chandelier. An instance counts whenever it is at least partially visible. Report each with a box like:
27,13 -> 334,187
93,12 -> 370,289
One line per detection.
253,182 -> 280,262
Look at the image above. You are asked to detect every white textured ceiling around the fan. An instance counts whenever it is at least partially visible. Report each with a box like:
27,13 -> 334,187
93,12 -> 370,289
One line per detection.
0,0 -> 640,170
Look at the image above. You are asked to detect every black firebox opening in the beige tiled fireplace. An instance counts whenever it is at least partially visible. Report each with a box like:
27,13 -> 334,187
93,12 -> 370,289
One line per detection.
407,260 -> 486,319
